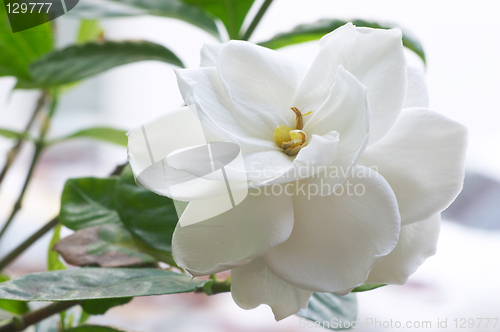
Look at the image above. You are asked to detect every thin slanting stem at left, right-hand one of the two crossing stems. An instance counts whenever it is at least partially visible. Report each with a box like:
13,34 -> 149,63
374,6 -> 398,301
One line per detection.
0,92 -> 58,243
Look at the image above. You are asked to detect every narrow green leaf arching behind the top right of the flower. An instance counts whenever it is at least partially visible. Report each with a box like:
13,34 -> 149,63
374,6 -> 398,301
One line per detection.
259,19 -> 425,64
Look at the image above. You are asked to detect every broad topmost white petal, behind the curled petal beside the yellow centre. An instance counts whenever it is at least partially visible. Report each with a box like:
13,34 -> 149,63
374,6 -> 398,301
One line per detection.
295,23 -> 407,143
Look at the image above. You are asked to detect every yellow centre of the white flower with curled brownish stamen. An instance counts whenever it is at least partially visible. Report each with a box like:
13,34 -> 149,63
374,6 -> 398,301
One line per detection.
274,107 -> 312,156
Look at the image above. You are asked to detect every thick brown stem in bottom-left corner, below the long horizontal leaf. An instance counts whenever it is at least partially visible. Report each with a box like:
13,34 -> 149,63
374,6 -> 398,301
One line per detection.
0,301 -> 80,332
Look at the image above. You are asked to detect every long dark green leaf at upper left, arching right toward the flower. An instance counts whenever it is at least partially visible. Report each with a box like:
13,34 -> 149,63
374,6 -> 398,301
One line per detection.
30,41 -> 183,87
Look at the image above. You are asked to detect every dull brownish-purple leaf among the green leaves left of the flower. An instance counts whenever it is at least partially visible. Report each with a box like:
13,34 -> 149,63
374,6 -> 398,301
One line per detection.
54,224 -> 157,267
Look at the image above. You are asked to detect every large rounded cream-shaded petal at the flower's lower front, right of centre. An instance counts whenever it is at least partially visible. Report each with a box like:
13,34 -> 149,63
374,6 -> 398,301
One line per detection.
263,166 -> 400,292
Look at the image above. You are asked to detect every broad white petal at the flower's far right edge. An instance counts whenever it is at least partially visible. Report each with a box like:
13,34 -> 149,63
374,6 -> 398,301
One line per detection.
359,108 -> 467,224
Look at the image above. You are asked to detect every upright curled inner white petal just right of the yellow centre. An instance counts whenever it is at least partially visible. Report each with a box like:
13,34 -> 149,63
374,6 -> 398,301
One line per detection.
299,66 -> 370,195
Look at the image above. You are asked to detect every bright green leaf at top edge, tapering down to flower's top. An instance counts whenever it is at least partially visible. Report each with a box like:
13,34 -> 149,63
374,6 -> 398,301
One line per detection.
183,0 -> 254,39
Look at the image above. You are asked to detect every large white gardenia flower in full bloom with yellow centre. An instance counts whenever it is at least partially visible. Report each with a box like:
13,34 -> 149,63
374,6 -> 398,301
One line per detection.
129,24 -> 467,320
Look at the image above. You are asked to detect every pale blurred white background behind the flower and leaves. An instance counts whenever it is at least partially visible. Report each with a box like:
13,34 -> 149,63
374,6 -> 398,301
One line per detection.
0,0 -> 500,332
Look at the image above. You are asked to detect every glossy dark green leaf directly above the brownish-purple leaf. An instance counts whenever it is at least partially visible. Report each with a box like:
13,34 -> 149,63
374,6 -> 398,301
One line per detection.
59,178 -> 121,230
